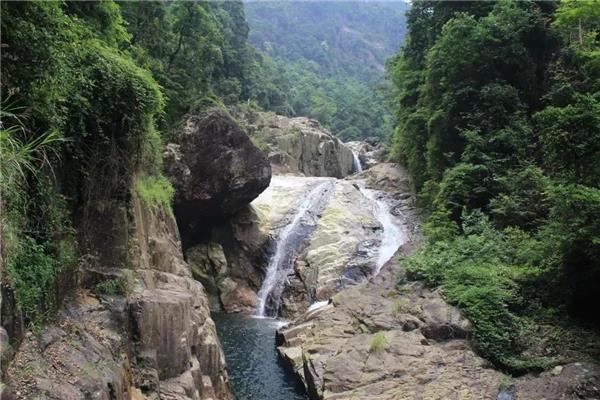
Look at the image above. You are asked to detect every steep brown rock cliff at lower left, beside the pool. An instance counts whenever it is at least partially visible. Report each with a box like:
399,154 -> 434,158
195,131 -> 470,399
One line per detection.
6,196 -> 231,400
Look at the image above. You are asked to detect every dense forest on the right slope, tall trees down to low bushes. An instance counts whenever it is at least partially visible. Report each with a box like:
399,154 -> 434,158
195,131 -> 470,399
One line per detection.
390,1 -> 600,371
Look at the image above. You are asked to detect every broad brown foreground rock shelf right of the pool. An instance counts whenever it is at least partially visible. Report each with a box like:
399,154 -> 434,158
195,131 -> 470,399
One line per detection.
277,273 -> 600,400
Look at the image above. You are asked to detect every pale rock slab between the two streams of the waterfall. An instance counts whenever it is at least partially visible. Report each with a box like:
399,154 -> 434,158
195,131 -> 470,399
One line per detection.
280,181 -> 381,318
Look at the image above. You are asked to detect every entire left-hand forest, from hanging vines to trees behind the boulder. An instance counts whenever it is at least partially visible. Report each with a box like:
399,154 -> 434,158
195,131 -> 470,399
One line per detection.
0,1 -> 285,330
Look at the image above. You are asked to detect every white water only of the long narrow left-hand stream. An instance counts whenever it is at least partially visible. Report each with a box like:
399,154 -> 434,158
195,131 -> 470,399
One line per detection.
256,180 -> 332,316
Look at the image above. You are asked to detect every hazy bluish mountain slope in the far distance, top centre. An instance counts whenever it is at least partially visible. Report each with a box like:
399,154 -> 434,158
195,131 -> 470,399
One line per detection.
245,1 -> 409,78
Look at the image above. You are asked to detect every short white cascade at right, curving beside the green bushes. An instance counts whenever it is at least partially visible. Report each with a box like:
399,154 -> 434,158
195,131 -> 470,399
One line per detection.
361,188 -> 407,276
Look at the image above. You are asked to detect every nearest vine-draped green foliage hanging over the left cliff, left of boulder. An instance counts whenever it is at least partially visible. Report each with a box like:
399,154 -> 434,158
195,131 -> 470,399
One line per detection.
0,1 -> 164,326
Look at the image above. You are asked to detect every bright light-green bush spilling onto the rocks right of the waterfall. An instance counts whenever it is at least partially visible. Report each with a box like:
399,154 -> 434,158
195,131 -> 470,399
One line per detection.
402,211 -> 552,368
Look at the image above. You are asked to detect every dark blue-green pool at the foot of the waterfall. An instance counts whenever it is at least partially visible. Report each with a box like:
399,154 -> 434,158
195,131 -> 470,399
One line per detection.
212,313 -> 307,400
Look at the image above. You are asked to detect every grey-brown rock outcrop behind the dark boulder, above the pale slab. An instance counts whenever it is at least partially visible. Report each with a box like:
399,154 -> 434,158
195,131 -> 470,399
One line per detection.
233,110 -> 354,178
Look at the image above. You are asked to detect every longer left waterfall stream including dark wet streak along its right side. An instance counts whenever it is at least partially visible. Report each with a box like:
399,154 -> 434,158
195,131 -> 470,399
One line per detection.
256,179 -> 333,317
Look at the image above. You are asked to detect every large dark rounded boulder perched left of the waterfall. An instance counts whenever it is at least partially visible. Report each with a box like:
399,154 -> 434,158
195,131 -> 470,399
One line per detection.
164,108 -> 271,224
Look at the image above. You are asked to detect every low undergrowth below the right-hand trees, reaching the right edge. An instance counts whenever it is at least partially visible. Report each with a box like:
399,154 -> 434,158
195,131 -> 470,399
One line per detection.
401,211 -> 600,374
